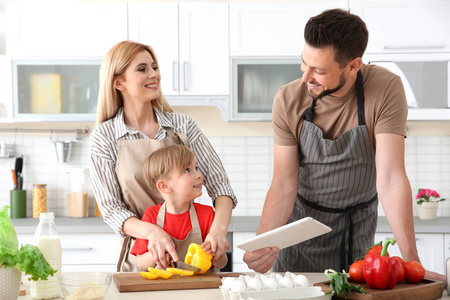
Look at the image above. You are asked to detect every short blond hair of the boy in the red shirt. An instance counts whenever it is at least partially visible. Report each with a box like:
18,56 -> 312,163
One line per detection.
142,145 -> 195,192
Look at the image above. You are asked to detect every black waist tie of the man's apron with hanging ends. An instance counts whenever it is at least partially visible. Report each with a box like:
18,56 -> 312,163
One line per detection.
297,193 -> 378,272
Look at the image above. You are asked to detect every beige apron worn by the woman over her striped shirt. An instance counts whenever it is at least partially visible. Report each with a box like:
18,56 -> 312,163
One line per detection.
116,127 -> 189,272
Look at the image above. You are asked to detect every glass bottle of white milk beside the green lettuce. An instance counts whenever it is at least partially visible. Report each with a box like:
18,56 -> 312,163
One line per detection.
30,212 -> 62,299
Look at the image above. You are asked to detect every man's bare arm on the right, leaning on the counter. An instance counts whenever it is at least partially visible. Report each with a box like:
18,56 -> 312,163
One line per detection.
375,133 -> 446,282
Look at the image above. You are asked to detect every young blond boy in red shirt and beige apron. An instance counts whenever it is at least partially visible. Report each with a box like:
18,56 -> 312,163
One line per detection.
130,145 -> 227,270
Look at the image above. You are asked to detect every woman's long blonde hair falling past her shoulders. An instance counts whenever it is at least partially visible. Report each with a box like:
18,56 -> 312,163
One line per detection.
97,41 -> 173,125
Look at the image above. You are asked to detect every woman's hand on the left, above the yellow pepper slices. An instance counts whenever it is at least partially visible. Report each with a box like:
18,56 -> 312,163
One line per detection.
148,226 -> 178,269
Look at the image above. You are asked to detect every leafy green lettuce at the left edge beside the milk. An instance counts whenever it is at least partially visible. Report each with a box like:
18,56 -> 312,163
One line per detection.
0,206 -> 57,281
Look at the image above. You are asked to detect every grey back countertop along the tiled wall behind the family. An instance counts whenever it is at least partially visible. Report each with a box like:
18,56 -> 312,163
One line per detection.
11,216 -> 450,234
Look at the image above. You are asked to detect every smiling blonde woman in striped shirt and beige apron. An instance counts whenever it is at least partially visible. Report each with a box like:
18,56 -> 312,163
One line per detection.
90,41 -> 237,271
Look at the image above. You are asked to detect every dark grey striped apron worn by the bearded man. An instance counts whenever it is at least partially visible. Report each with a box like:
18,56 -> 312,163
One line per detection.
273,71 -> 378,272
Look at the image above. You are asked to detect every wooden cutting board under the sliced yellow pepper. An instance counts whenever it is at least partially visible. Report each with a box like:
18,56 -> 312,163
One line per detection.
113,272 -> 243,293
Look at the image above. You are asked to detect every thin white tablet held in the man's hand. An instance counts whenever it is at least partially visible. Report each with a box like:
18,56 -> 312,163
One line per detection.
236,217 -> 331,252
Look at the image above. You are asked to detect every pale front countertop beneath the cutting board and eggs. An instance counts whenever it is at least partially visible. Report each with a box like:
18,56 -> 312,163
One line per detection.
18,273 -> 450,300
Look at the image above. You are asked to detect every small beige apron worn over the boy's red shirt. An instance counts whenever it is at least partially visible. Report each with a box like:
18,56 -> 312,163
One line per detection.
156,202 -> 203,261
